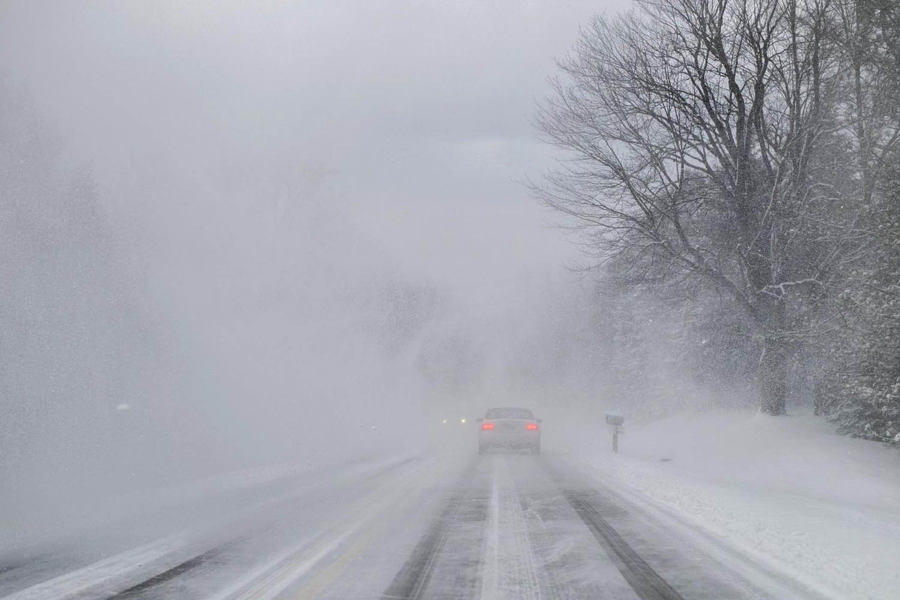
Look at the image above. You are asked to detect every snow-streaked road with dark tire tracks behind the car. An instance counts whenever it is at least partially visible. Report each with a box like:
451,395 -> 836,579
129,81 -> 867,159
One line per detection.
0,453 -> 828,600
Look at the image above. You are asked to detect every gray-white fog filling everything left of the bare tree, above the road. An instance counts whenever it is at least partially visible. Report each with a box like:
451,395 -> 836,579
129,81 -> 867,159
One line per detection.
0,1 -> 660,542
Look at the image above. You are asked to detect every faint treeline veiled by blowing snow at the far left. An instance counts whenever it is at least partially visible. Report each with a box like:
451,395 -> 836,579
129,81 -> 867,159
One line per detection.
0,74 -> 199,524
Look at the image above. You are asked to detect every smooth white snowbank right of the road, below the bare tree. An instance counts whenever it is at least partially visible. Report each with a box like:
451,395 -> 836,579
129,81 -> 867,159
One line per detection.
581,411 -> 900,600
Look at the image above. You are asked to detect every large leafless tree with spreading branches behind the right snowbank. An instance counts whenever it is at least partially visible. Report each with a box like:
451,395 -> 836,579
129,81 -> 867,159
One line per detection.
537,0 -> 857,414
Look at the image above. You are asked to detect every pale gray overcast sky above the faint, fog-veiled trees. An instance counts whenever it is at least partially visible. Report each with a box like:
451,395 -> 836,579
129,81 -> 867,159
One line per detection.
0,0 -> 626,318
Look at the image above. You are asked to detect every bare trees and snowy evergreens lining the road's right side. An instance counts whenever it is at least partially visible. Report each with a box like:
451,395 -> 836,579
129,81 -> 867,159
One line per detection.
537,0 -> 900,443
